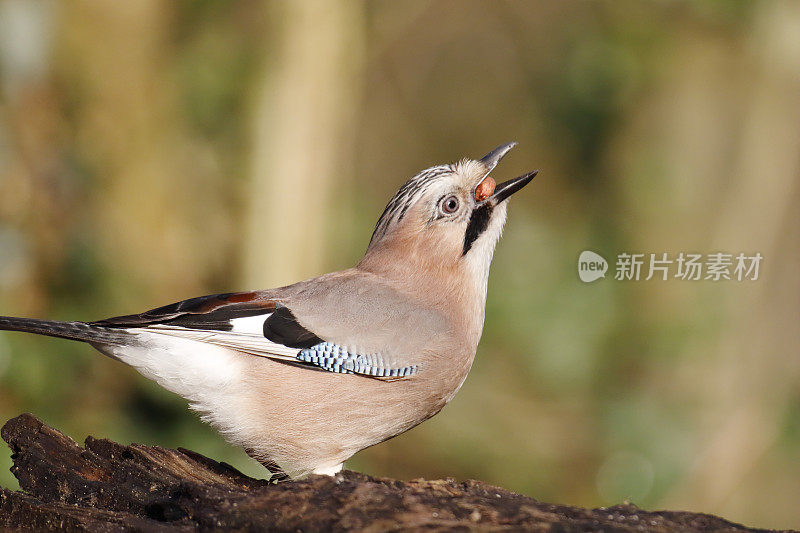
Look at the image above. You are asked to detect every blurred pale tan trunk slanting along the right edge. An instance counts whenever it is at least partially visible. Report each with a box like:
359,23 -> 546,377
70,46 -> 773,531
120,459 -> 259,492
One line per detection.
665,2 -> 800,518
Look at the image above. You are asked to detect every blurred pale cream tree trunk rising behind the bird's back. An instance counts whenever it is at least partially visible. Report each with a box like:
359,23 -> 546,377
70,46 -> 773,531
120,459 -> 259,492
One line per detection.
243,0 -> 364,287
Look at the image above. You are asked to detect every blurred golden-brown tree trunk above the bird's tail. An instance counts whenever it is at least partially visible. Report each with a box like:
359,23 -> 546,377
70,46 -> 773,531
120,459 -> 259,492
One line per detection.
57,0 -> 208,313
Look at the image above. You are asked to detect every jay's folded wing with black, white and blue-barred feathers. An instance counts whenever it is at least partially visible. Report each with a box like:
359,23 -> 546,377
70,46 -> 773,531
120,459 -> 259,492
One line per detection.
91,292 -> 417,380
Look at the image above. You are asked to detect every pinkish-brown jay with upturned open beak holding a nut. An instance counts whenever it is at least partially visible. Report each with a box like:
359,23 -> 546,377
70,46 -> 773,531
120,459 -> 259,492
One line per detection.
0,142 -> 538,481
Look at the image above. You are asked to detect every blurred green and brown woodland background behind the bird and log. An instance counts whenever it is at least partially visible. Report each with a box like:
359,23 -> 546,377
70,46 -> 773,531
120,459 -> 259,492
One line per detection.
0,0 -> 800,527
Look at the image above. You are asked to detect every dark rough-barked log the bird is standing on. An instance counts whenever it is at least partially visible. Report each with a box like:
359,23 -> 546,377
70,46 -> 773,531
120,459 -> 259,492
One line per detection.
0,414 -> 784,532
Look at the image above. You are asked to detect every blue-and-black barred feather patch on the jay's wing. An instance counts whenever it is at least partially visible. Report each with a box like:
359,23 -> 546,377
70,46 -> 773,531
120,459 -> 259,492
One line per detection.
297,342 -> 417,378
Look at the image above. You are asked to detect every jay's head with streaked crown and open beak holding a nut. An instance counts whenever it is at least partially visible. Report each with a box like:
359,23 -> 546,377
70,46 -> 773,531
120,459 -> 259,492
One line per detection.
359,142 -> 537,300
